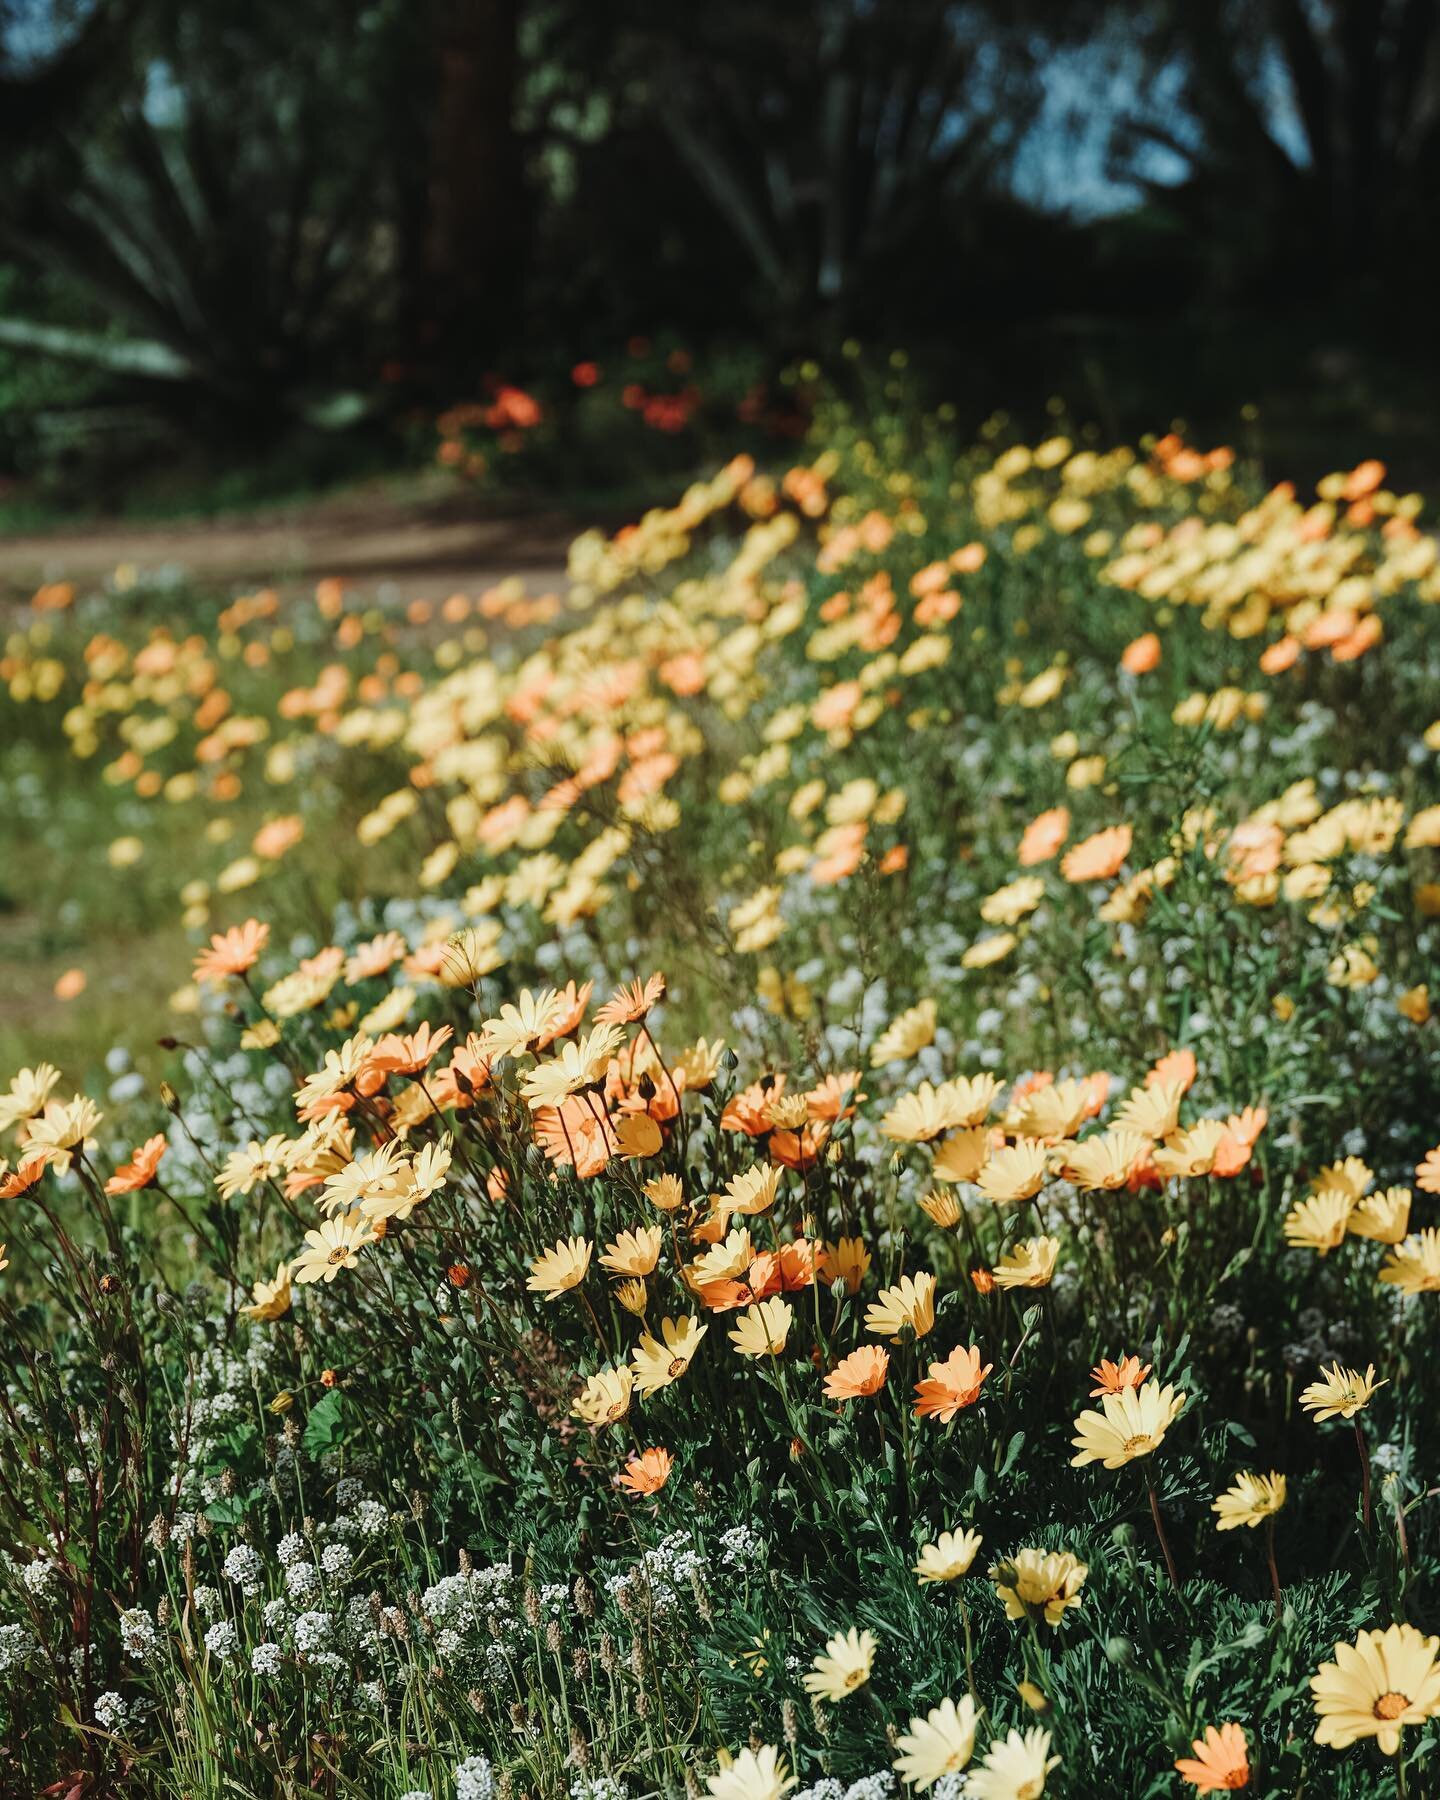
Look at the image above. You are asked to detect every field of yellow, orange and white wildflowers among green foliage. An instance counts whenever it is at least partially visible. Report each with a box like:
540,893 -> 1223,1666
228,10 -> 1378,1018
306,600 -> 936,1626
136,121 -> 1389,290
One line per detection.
0,407 -> 1440,1800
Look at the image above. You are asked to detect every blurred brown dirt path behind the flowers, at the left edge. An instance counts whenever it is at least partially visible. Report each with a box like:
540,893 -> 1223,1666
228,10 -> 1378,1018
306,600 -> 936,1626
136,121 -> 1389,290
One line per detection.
0,481 -> 583,599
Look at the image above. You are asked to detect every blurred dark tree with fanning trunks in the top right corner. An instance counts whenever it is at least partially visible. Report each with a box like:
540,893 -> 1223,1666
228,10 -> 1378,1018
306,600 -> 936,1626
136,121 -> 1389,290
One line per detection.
1111,0 -> 1440,288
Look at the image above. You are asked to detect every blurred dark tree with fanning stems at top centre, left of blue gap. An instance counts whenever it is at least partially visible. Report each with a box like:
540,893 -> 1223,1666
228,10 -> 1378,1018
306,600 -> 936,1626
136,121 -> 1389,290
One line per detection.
536,0 -> 1055,333
